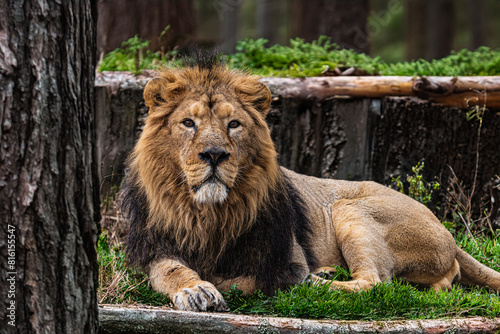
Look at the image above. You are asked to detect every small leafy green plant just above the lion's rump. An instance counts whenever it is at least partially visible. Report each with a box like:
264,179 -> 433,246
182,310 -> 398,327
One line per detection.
392,161 -> 441,205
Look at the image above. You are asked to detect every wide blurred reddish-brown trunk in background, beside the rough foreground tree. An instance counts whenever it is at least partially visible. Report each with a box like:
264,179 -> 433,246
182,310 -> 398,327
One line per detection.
97,0 -> 196,54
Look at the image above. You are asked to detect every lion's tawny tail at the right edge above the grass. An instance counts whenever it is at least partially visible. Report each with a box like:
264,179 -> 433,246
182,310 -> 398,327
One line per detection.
457,248 -> 500,291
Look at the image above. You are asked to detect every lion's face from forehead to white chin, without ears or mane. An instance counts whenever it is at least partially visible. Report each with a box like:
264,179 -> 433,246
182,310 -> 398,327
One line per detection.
169,92 -> 255,203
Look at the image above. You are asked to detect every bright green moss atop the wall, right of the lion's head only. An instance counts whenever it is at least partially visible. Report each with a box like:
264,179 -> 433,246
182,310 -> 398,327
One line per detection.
229,36 -> 500,77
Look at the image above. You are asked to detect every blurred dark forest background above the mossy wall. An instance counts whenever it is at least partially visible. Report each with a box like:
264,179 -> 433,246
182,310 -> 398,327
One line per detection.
98,0 -> 500,62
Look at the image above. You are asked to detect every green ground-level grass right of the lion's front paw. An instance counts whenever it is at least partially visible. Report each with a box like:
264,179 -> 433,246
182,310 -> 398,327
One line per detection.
224,235 -> 500,320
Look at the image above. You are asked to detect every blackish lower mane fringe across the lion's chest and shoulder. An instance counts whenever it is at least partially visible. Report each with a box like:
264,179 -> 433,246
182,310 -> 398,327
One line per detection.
122,171 -> 317,294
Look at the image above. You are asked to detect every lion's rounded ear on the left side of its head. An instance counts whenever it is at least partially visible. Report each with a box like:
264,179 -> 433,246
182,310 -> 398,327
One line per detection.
144,75 -> 184,110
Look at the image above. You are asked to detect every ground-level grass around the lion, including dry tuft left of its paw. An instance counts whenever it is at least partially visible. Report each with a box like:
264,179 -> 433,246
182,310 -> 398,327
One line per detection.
98,233 -> 500,320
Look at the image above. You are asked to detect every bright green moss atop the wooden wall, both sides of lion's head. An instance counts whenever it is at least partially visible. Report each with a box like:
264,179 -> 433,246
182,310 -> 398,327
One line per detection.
99,36 -> 500,77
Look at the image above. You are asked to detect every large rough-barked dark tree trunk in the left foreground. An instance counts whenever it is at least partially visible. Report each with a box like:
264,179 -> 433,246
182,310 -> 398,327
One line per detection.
0,0 -> 99,333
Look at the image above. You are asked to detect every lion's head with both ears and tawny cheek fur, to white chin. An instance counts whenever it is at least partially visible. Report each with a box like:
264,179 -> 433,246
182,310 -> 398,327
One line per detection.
137,65 -> 275,204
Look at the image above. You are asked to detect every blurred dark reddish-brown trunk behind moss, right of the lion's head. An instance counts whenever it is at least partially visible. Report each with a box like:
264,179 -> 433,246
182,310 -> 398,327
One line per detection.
292,0 -> 370,53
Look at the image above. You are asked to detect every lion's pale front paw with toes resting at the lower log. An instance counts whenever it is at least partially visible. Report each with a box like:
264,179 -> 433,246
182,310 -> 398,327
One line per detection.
173,282 -> 228,311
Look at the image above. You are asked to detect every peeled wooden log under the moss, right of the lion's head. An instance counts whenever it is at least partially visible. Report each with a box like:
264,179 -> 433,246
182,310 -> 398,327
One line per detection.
261,76 -> 500,109
